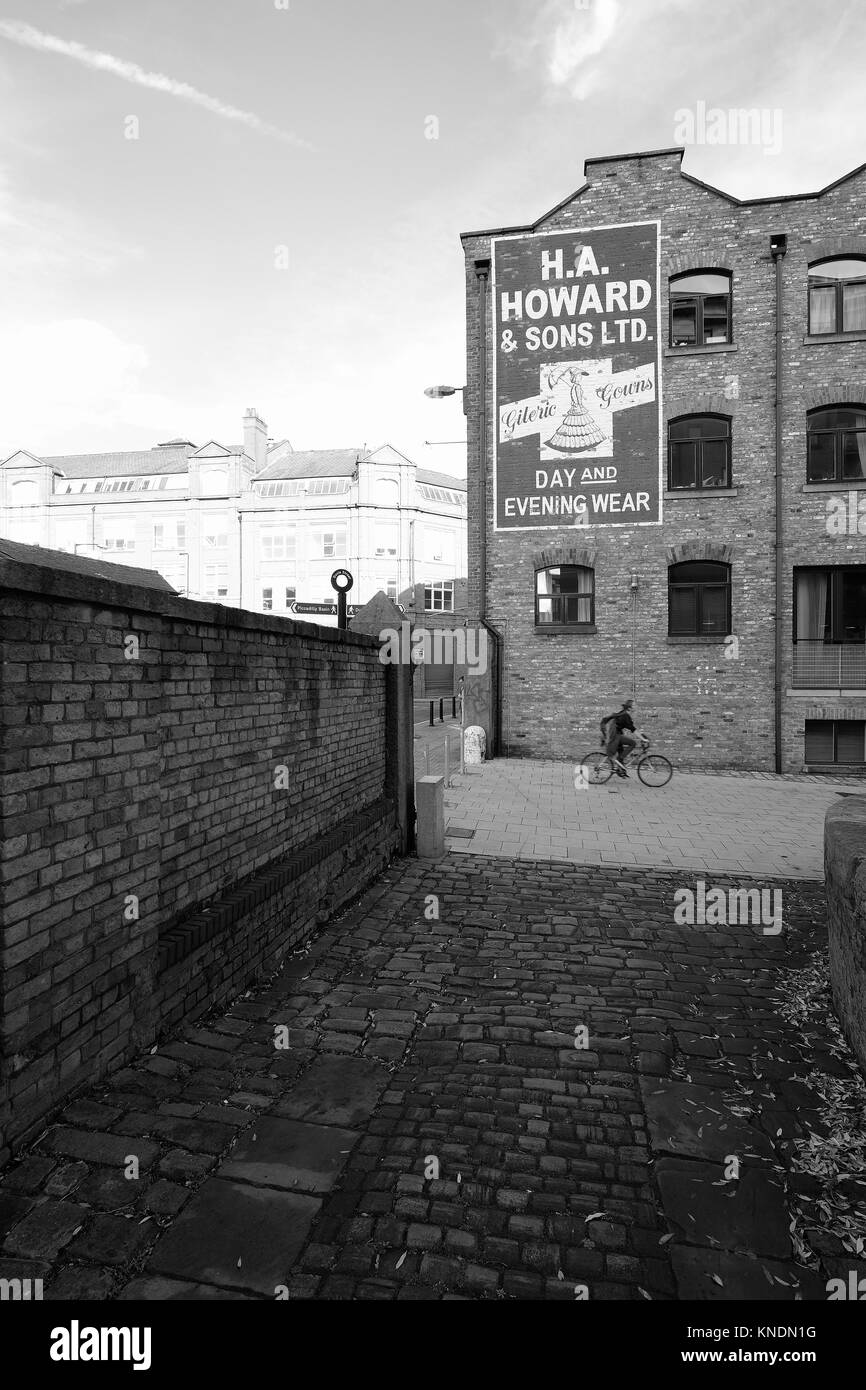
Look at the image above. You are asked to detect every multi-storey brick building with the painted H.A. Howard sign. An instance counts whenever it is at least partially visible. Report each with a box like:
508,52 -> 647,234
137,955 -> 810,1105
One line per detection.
463,149 -> 866,773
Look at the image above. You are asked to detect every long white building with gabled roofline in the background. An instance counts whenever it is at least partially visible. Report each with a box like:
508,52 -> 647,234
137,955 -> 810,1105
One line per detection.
0,410 -> 466,623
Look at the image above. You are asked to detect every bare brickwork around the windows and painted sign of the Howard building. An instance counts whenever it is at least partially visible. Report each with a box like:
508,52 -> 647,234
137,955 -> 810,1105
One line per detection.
464,152 -> 866,771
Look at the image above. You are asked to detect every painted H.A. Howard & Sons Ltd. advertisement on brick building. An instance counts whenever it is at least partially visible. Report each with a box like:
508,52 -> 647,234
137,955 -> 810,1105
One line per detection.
492,222 -> 662,531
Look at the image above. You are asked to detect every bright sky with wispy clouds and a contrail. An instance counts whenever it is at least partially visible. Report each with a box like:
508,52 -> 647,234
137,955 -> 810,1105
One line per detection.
0,0 -> 866,475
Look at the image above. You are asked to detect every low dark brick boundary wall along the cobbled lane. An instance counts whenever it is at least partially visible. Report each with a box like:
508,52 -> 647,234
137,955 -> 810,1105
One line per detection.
0,562 -> 411,1161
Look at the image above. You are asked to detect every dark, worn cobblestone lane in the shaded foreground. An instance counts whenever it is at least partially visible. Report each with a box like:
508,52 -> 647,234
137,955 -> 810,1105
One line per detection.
0,856 -> 855,1300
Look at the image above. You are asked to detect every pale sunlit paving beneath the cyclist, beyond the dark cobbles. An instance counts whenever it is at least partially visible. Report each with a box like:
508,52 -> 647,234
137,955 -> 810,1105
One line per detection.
436,756 -> 863,878
